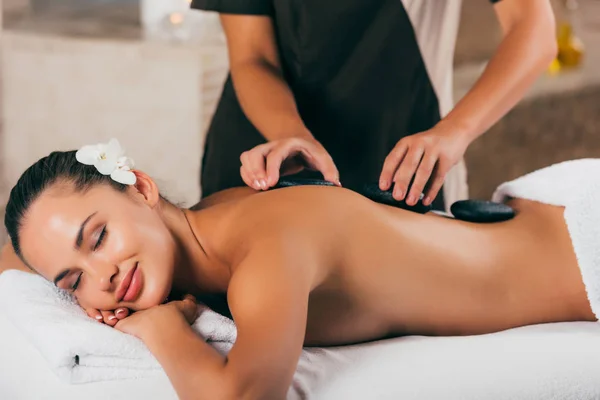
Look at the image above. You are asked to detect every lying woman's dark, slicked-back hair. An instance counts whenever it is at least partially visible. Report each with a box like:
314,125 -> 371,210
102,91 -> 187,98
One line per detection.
4,150 -> 127,264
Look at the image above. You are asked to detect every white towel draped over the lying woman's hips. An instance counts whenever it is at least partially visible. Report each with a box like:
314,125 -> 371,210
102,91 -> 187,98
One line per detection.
492,159 -> 600,319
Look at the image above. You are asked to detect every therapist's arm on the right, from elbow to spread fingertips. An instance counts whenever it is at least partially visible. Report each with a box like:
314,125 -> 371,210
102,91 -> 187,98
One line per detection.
380,0 -> 557,205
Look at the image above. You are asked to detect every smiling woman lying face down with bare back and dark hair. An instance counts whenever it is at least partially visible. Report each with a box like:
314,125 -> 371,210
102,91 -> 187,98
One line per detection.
5,141 -> 596,399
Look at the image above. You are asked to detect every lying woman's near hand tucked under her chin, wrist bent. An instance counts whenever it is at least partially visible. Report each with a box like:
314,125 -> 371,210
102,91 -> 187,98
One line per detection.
114,295 -> 198,340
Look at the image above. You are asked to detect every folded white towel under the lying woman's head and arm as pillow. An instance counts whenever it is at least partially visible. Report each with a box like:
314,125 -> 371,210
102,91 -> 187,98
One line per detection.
0,270 -> 237,383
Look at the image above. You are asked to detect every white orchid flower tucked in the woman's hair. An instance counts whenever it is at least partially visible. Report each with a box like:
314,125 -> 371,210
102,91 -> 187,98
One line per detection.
75,139 -> 136,185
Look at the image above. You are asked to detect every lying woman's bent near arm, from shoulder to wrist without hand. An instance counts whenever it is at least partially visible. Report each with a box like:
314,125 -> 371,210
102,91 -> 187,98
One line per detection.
142,244 -> 315,400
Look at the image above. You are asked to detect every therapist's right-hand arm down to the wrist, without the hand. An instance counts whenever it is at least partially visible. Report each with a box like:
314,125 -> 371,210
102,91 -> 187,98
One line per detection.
440,0 -> 557,142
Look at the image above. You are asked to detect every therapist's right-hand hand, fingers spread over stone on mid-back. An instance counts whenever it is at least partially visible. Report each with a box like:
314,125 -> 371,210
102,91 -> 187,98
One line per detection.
379,127 -> 470,206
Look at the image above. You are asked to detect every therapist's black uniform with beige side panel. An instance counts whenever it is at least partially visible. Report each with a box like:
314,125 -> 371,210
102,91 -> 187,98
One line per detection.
192,0 -> 500,209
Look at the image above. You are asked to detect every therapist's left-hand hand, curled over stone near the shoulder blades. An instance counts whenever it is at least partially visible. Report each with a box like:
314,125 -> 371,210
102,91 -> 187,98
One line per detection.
240,137 -> 341,190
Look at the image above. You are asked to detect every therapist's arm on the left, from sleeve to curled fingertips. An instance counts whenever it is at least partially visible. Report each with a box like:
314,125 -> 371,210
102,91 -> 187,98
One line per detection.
221,14 -> 340,190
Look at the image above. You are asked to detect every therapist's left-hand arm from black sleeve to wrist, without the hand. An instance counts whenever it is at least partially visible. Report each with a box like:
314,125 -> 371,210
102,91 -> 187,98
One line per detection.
221,14 -> 312,141
